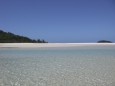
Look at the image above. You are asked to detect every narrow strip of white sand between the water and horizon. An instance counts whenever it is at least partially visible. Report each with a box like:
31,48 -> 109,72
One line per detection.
0,43 -> 115,48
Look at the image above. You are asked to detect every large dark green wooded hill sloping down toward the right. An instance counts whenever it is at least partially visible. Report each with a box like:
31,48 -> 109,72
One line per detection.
0,30 -> 48,43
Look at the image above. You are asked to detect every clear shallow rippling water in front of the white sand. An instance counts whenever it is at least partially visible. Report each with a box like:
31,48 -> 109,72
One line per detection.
0,45 -> 115,86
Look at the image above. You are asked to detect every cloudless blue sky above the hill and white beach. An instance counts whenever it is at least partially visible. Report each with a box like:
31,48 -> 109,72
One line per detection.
0,0 -> 115,43
